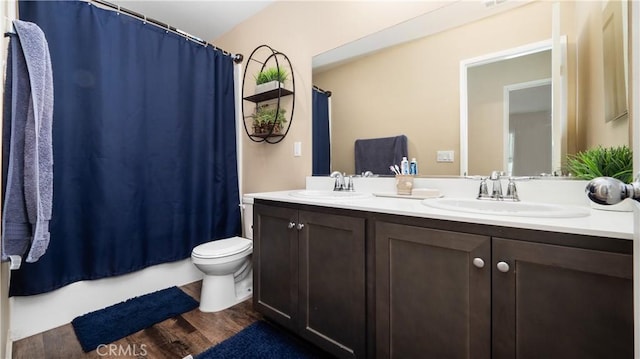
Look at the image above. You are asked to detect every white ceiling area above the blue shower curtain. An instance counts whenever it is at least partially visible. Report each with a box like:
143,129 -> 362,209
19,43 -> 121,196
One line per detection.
108,0 -> 273,42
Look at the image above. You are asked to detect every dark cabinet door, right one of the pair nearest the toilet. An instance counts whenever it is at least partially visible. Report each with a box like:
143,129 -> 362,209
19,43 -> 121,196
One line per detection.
299,211 -> 365,358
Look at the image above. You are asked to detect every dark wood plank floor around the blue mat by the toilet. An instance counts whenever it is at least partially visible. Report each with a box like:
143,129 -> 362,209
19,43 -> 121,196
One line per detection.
13,281 -> 262,359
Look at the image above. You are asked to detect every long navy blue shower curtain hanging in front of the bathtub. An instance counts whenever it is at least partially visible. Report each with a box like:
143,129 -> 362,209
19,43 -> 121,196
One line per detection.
10,1 -> 240,295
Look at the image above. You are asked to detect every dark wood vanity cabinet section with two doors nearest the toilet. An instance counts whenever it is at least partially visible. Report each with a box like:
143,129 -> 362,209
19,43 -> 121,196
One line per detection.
253,204 -> 365,358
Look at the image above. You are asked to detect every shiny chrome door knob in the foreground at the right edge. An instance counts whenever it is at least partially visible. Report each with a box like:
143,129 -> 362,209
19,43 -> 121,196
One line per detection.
585,173 -> 640,205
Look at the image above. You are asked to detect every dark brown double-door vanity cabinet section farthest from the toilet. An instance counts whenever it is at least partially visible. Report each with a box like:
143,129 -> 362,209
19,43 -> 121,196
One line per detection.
375,221 -> 633,359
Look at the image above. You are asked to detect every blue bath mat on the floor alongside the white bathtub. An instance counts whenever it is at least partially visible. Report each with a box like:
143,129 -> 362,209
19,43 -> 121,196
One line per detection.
71,287 -> 198,352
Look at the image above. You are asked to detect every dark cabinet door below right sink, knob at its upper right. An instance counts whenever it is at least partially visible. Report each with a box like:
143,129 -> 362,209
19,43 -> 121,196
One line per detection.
375,222 -> 491,359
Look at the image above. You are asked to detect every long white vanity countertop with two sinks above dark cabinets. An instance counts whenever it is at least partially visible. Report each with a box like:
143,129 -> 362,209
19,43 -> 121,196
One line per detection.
243,190 -> 633,240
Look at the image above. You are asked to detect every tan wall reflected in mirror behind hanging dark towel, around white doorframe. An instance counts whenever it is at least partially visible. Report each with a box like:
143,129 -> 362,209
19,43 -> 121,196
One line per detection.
313,2 -> 568,175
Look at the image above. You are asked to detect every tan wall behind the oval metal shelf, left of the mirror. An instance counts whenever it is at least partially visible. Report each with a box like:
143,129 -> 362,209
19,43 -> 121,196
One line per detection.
214,1 -> 441,193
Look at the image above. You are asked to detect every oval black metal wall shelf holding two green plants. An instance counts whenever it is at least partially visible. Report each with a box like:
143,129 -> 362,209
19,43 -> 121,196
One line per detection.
242,45 -> 296,144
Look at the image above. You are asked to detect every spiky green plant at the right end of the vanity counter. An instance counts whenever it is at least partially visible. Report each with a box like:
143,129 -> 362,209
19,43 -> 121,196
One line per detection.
567,146 -> 633,183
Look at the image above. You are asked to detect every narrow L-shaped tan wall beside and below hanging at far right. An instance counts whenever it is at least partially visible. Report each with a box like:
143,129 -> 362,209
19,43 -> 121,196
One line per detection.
576,1 -> 631,151
